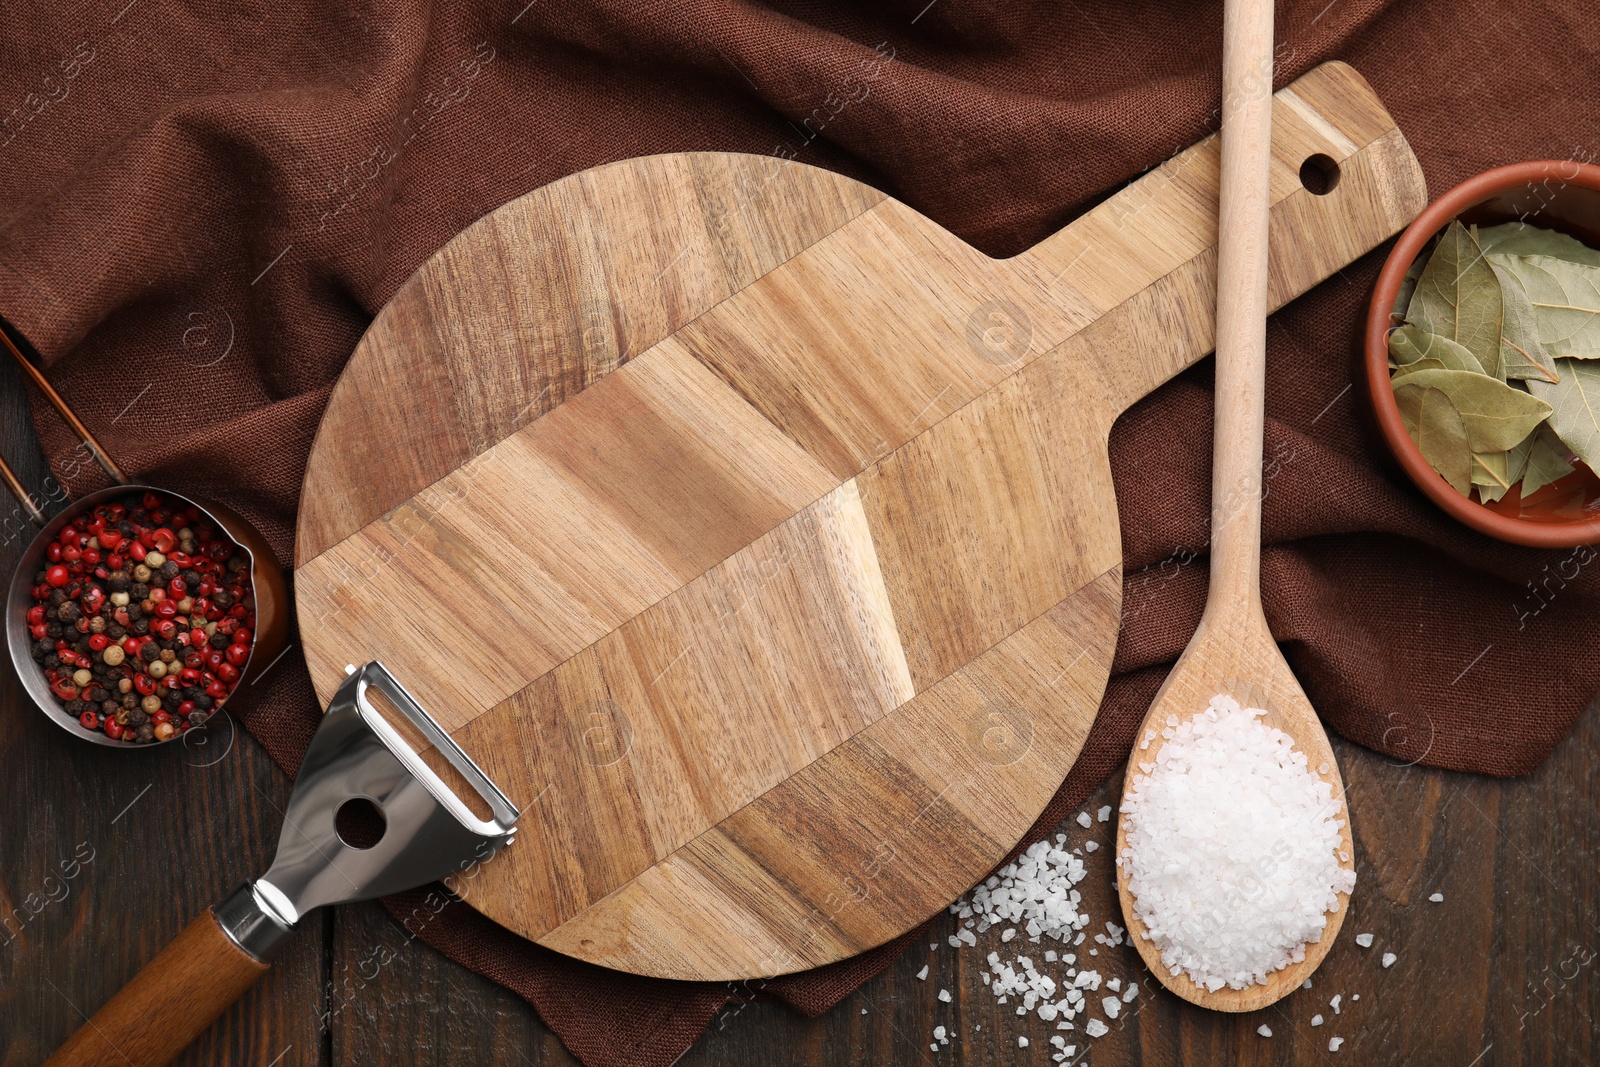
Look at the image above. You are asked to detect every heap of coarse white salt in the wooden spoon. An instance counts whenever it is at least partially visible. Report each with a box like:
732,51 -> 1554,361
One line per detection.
1118,696 -> 1355,992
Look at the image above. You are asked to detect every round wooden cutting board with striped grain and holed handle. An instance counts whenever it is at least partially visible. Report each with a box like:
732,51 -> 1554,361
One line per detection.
296,64 -> 1426,979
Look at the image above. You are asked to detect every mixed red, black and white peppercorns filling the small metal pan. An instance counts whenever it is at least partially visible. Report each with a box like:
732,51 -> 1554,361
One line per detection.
27,493 -> 256,744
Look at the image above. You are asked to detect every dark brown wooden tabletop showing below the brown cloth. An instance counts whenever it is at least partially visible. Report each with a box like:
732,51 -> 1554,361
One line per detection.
0,362 -> 1600,1067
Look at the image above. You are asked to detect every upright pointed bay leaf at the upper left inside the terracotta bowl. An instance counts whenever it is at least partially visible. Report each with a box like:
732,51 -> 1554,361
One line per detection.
1406,222 -> 1502,378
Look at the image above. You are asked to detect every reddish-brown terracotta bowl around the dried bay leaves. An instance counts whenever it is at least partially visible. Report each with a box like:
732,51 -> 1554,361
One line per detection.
1365,160 -> 1600,549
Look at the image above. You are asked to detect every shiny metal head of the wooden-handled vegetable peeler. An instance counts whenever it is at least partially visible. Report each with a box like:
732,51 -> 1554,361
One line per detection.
216,661 -> 520,960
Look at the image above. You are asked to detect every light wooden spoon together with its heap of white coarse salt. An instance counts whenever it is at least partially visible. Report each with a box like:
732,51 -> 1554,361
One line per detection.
1117,0 -> 1355,1011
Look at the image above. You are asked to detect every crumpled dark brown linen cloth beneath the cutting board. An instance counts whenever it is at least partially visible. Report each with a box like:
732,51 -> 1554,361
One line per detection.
0,0 -> 1600,1065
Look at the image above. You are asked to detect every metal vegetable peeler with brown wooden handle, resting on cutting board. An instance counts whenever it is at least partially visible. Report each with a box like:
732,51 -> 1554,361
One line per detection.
46,662 -> 518,1067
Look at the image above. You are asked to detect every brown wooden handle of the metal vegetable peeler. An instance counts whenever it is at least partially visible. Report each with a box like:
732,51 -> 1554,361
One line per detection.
45,909 -> 267,1067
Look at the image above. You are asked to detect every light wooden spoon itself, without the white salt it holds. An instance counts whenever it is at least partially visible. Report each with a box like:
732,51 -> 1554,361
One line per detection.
1117,0 -> 1354,1011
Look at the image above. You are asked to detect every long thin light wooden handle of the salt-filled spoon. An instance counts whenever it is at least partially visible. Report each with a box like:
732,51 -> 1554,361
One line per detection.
1206,0 -> 1272,614
